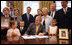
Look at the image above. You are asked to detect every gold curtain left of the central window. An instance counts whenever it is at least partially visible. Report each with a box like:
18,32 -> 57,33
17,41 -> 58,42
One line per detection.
7,1 -> 23,15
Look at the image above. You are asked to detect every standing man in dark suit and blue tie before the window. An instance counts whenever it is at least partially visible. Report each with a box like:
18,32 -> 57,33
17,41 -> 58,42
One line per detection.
22,7 -> 33,30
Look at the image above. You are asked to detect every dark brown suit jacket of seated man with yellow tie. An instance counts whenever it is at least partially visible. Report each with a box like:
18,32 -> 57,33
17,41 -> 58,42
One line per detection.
25,23 -> 45,35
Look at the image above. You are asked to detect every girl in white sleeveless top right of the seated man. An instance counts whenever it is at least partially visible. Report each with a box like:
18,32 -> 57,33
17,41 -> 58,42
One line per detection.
48,19 -> 58,36
